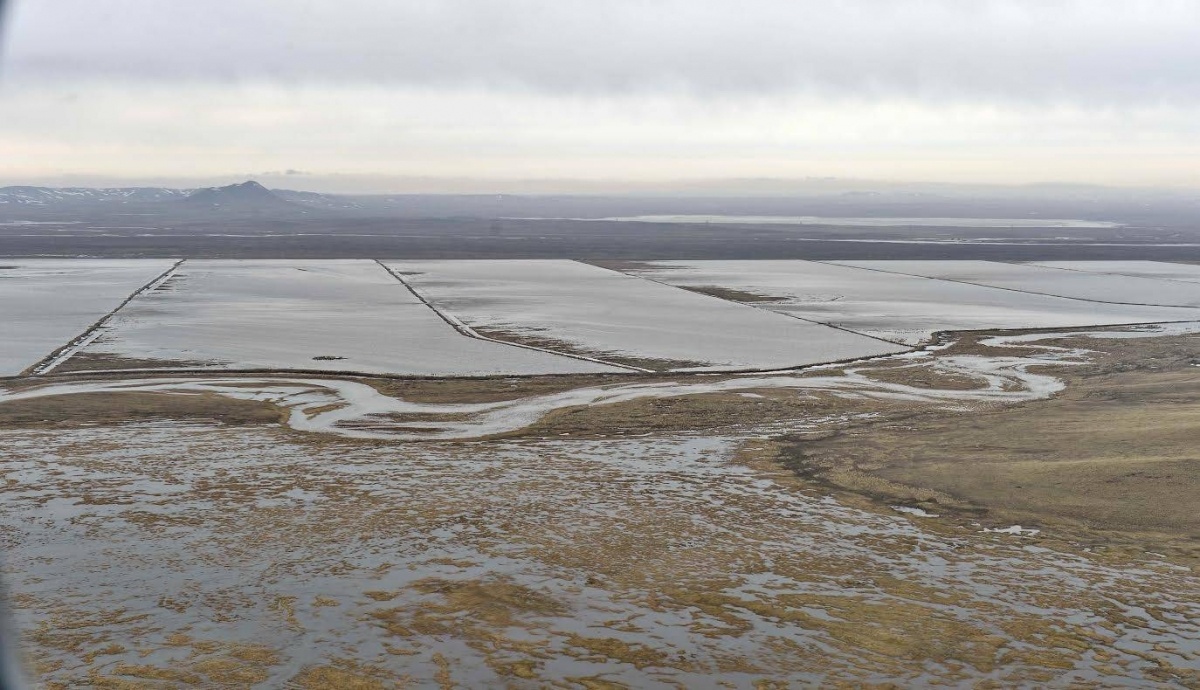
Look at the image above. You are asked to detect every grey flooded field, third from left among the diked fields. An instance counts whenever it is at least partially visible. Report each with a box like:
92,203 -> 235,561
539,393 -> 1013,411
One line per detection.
388,260 -> 902,368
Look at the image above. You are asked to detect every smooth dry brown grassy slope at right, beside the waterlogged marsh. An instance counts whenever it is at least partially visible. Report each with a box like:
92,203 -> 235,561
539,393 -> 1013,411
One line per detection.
780,337 -> 1200,561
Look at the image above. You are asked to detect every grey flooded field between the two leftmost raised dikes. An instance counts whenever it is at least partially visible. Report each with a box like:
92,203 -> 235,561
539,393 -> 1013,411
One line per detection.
59,260 -> 619,376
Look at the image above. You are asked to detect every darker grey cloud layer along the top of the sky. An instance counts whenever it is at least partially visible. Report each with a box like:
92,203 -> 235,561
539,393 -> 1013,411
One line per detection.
6,0 -> 1200,104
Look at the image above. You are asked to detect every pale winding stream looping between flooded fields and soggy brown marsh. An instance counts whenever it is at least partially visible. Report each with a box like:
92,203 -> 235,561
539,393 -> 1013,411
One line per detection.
0,324 -> 1180,440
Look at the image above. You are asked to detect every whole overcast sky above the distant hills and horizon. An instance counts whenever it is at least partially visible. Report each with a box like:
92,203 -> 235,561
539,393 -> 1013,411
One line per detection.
0,0 -> 1200,192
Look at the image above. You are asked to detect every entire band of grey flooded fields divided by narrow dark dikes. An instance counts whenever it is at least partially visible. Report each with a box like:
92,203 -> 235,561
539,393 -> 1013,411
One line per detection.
9,259 -> 1200,377
